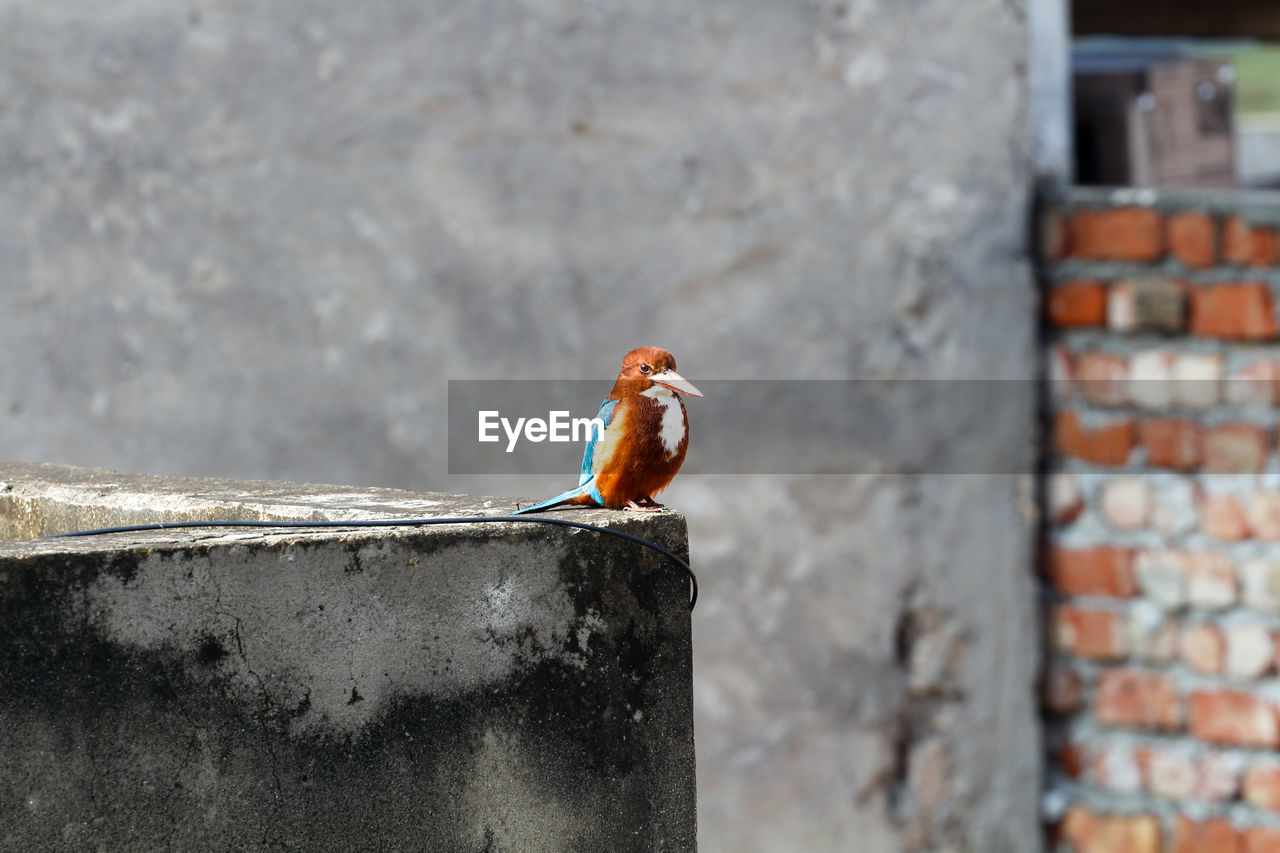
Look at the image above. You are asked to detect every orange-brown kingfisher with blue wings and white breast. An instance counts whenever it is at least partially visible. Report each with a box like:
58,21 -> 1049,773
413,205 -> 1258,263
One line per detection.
516,347 -> 703,515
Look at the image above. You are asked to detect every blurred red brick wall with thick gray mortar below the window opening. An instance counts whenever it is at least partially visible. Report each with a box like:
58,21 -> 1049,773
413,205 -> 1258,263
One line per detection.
1041,191 -> 1280,853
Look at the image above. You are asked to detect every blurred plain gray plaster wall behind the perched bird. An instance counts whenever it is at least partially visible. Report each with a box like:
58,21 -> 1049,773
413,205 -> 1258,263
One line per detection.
0,0 -> 1039,853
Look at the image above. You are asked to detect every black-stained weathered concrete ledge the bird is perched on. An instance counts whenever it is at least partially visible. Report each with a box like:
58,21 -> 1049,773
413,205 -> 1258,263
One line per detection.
0,465 -> 695,850
